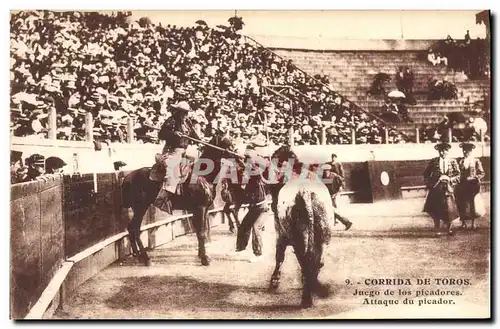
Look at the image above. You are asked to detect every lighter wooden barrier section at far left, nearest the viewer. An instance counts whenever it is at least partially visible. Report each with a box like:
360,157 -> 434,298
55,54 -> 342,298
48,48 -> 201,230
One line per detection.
10,177 -> 65,318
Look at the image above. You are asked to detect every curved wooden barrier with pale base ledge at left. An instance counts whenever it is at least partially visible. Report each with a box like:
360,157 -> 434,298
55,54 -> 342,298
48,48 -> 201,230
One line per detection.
10,171 -> 229,319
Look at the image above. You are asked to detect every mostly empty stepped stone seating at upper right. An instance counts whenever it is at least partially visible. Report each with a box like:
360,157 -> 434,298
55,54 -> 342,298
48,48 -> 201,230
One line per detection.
273,49 -> 490,138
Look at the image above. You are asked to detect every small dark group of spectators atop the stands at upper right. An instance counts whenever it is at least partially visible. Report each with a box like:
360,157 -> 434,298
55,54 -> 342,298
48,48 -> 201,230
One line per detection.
427,30 -> 490,78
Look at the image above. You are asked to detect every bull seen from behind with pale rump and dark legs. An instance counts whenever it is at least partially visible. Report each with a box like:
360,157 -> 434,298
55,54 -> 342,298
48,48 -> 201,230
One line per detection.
269,146 -> 335,308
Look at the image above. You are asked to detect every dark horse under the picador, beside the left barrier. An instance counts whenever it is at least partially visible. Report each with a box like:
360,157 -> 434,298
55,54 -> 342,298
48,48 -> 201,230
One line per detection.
122,135 -> 233,266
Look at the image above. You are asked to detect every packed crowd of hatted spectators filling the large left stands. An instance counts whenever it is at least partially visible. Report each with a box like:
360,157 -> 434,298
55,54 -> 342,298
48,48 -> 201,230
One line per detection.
10,11 -> 403,145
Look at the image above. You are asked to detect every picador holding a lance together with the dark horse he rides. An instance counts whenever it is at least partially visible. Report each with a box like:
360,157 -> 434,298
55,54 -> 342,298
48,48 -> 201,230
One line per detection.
122,98 -> 234,266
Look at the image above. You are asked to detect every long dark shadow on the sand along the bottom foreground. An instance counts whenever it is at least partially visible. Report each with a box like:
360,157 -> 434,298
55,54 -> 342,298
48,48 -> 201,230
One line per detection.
105,275 -> 350,318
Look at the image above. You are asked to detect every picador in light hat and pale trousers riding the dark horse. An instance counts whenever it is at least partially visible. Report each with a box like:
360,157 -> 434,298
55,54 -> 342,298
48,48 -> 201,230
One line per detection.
149,101 -> 201,212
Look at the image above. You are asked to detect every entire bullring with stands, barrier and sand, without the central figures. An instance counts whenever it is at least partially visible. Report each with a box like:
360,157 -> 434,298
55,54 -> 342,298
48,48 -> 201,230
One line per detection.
10,11 -> 491,319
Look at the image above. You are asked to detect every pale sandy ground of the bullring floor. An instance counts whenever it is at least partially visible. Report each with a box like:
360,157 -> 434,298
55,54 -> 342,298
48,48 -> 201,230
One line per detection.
54,193 -> 490,319
